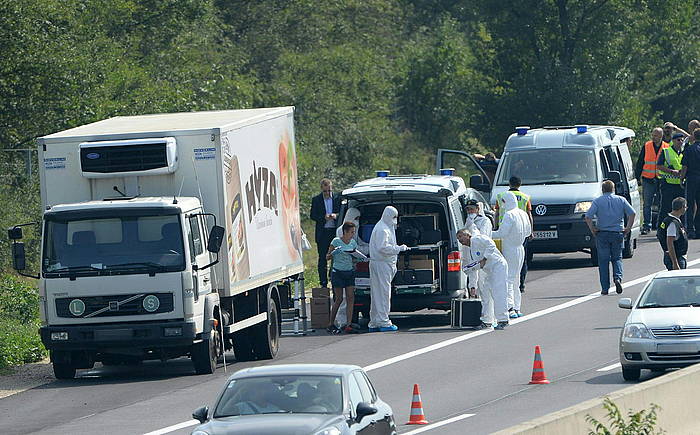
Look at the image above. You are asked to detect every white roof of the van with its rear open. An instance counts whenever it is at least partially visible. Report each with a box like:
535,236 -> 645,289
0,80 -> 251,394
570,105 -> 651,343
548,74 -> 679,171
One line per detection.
343,174 -> 467,199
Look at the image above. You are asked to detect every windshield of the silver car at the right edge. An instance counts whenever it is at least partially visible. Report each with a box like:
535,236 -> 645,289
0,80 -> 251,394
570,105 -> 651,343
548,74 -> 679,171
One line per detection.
637,276 -> 700,308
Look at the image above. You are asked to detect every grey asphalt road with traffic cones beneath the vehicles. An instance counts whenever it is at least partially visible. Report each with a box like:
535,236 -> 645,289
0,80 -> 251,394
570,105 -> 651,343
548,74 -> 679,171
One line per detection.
0,235 -> 700,434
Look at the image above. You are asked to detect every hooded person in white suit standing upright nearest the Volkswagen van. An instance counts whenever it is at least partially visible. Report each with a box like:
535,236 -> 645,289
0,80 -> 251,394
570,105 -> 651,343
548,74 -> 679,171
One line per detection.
491,191 -> 532,319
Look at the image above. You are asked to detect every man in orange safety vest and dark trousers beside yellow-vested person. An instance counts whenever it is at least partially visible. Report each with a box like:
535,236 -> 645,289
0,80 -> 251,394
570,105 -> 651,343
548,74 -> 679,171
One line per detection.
635,127 -> 668,234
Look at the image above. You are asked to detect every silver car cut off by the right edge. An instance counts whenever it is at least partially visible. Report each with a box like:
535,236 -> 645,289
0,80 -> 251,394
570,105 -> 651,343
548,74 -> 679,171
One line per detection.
618,269 -> 700,381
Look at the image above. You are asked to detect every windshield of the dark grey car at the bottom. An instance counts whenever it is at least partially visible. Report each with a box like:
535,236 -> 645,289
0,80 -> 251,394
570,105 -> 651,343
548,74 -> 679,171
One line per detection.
214,375 -> 343,418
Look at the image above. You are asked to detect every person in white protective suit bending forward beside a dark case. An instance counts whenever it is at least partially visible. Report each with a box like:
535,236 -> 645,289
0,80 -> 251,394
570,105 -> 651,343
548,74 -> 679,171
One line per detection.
457,227 -> 508,329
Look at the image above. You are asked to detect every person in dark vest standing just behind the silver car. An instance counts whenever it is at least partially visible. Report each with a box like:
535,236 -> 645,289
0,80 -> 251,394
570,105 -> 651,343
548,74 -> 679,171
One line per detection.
656,197 -> 688,270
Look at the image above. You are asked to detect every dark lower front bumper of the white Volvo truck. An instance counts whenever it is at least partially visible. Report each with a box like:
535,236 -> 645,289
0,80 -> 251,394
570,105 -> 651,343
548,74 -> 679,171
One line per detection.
39,321 -> 196,351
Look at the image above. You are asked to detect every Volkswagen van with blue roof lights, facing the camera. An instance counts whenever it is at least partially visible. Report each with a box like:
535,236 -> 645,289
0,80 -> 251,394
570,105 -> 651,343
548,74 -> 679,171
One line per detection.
484,125 -> 641,264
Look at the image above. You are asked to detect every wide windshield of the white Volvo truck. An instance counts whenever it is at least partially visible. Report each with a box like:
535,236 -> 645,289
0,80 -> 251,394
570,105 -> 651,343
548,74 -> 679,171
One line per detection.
42,215 -> 185,277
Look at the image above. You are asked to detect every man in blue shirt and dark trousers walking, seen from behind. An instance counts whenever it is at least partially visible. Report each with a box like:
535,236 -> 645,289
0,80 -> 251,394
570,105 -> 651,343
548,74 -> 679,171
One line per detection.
586,180 -> 635,295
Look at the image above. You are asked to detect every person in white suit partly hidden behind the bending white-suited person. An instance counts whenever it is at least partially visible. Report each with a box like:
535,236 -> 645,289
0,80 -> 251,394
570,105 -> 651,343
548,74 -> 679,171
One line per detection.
462,199 -> 494,325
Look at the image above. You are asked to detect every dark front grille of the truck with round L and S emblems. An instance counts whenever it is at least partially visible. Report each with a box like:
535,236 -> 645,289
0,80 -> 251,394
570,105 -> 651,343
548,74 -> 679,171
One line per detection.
56,293 -> 173,319
